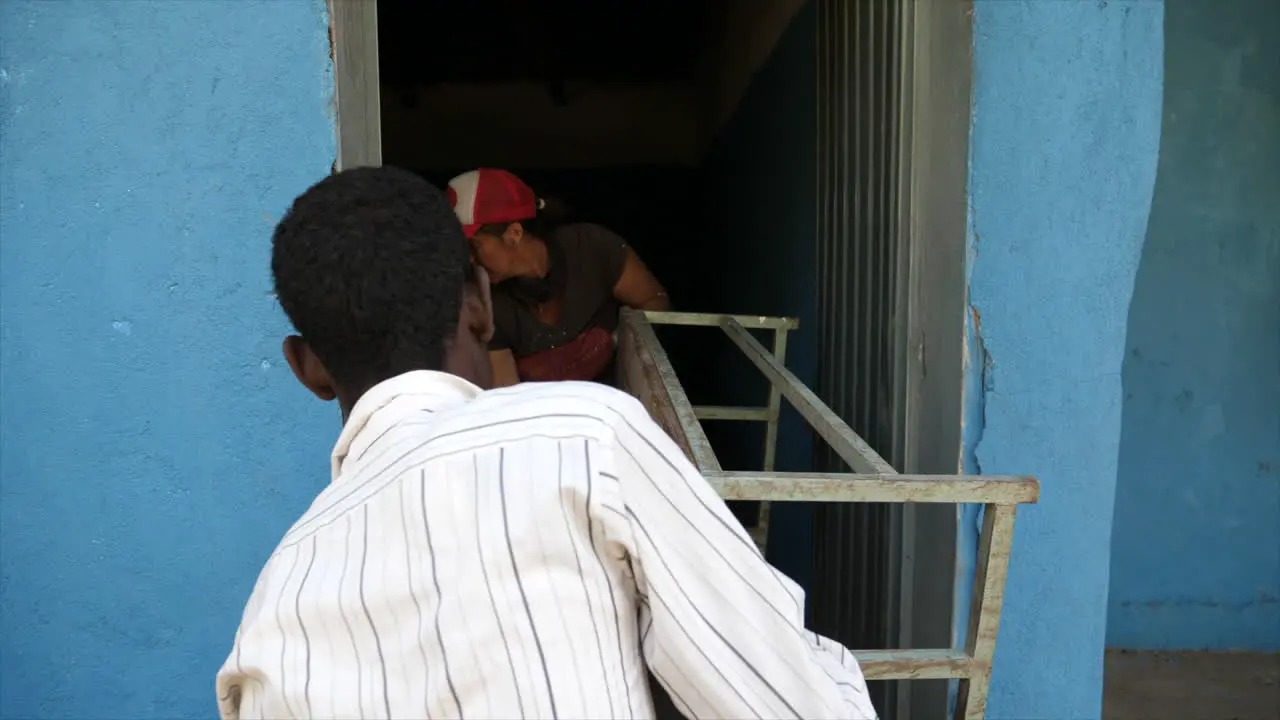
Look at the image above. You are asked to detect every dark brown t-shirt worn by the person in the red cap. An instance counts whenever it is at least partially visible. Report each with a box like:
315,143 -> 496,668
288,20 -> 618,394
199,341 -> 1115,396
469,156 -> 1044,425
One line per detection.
489,223 -> 627,379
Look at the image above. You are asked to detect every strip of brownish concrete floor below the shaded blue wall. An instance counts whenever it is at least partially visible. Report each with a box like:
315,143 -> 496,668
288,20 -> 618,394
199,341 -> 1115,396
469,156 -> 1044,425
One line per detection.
1102,650 -> 1280,720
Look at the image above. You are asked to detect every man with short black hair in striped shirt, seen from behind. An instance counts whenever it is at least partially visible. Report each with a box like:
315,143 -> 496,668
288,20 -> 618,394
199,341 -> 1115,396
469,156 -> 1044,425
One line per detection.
216,168 -> 874,719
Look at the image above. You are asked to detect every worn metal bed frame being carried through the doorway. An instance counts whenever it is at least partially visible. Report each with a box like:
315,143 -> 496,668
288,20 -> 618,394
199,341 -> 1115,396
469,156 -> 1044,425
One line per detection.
618,310 -> 1039,720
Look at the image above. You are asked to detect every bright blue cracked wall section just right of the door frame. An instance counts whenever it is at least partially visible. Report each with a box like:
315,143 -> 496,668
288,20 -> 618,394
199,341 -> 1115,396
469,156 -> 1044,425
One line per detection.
965,0 -> 1164,720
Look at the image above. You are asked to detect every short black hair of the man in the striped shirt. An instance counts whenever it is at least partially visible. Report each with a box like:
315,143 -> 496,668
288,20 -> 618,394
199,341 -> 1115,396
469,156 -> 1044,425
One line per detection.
271,168 -> 475,387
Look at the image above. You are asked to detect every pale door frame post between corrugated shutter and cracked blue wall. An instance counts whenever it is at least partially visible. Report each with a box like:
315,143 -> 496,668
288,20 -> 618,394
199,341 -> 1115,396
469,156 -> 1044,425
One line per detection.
897,0 -> 973,720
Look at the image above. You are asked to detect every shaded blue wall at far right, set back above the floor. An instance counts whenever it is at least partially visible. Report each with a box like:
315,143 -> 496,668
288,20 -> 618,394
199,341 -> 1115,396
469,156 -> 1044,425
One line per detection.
1107,0 -> 1280,651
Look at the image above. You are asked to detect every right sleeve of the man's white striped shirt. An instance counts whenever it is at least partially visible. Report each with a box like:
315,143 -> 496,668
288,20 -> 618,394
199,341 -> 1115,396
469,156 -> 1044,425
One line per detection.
601,392 -> 876,720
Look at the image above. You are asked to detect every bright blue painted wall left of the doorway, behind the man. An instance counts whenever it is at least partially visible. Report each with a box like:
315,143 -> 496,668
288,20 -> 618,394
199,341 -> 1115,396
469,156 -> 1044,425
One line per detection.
0,0 -> 339,719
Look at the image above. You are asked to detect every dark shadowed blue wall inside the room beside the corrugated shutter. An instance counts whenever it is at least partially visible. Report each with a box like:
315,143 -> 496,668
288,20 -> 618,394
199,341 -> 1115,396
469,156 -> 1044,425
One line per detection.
694,3 -> 818,588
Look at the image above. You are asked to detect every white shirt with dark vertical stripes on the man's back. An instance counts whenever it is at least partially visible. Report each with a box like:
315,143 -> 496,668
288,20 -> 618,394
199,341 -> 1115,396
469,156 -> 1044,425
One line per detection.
218,372 -> 874,719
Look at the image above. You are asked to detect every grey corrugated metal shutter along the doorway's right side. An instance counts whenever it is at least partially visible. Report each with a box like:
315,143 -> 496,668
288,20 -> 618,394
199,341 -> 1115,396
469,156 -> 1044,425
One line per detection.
813,0 -> 909,717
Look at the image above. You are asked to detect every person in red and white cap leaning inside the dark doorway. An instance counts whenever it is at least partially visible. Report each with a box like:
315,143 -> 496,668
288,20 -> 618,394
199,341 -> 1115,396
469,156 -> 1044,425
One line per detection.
448,168 -> 669,387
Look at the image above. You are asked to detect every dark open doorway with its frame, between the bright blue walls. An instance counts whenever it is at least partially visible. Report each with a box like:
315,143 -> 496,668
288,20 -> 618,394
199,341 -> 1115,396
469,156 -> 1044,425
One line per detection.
322,0 -> 972,717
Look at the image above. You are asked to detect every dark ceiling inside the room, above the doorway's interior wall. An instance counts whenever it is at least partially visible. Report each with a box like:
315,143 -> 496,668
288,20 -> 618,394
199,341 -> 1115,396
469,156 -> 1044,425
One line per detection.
378,0 -> 804,170
